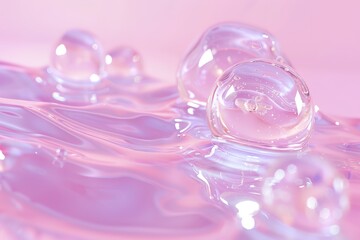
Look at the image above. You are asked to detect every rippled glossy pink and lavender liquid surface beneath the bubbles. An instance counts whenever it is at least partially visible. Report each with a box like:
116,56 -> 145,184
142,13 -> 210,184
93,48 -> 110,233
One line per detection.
0,27 -> 360,240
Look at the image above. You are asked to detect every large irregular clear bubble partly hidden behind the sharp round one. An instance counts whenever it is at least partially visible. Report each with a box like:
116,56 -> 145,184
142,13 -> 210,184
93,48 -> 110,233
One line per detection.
178,23 -> 285,104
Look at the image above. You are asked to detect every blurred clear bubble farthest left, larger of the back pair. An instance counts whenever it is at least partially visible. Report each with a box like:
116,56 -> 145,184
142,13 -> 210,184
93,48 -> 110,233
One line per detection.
49,30 -> 104,83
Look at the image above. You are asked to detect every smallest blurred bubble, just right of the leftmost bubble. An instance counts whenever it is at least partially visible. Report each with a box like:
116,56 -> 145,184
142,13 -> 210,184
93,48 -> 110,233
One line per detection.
105,47 -> 142,76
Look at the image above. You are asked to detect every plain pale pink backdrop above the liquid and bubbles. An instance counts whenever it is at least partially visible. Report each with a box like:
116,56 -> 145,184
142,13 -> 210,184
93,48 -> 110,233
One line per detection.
0,0 -> 360,117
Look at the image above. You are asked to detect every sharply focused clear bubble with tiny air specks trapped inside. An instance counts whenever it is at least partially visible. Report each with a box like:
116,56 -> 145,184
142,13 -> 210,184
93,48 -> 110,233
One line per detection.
207,60 -> 314,149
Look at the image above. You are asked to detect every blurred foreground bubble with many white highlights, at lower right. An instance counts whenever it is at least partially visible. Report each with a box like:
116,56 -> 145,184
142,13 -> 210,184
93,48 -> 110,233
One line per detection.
262,157 -> 349,234
